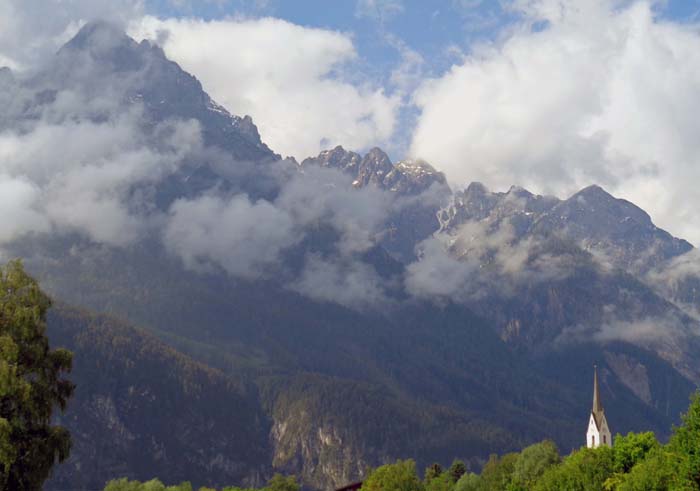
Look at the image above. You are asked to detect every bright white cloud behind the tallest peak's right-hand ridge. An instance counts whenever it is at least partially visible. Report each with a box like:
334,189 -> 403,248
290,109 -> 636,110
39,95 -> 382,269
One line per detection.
131,17 -> 399,159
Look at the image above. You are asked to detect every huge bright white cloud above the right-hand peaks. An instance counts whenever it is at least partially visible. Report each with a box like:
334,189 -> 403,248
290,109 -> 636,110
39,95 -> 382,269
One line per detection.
411,0 -> 700,243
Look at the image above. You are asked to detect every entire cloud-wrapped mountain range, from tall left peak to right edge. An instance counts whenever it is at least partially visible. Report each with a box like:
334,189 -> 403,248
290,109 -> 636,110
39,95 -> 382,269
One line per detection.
0,23 -> 700,489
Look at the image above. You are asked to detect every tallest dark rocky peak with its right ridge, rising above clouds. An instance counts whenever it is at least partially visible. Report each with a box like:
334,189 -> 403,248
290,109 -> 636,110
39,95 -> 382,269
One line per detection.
45,21 -> 279,161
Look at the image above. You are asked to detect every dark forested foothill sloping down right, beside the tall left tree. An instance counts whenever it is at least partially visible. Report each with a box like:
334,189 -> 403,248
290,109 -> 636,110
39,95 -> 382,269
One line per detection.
46,306 -> 271,489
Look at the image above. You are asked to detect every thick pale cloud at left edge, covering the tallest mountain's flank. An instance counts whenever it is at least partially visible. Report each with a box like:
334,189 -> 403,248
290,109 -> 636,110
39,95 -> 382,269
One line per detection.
0,103 -> 201,245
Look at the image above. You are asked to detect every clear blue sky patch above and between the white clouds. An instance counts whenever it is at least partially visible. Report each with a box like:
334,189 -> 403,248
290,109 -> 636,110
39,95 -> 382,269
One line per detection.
147,0 -> 700,82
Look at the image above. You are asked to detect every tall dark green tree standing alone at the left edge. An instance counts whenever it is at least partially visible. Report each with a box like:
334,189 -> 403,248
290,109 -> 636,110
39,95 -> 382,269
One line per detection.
0,261 -> 74,491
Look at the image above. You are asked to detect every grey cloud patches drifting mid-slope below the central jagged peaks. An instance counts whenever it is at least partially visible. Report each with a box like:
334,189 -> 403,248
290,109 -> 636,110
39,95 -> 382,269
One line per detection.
163,163 -> 391,290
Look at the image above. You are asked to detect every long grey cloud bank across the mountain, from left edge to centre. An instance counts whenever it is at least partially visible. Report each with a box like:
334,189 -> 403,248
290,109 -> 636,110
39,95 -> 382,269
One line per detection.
0,36 -> 400,307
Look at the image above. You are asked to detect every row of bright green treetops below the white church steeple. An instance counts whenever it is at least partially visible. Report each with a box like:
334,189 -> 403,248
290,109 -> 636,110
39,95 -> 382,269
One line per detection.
362,392 -> 700,491
